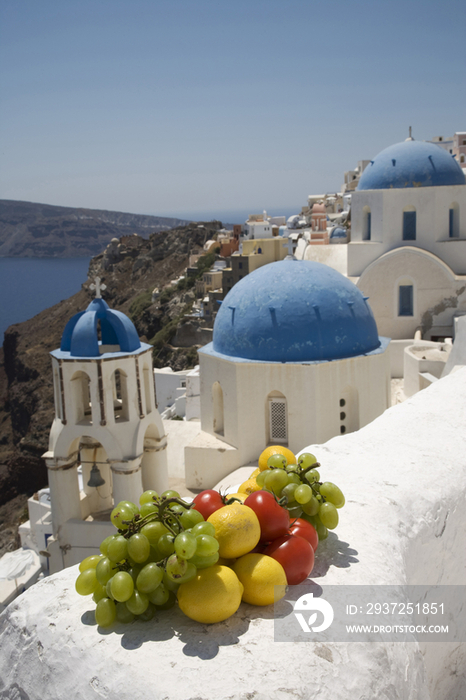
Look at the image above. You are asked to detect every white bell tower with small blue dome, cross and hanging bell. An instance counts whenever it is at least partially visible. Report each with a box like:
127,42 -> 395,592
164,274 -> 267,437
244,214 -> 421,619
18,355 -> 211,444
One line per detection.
39,279 -> 168,573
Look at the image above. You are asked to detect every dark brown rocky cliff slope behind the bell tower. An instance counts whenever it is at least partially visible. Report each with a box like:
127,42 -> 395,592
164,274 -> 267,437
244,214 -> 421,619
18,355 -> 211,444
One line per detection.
0,222 -> 221,505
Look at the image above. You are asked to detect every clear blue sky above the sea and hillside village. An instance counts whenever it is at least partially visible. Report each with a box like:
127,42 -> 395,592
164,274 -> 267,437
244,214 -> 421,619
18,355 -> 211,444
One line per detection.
0,0 -> 466,218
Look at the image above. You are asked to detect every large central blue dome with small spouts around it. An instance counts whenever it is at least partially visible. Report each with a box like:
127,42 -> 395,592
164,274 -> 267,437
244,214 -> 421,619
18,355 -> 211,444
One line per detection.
212,260 -> 381,362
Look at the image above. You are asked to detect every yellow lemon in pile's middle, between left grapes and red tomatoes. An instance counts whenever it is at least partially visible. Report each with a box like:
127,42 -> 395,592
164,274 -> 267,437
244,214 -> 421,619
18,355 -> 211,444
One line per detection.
207,502 -> 261,559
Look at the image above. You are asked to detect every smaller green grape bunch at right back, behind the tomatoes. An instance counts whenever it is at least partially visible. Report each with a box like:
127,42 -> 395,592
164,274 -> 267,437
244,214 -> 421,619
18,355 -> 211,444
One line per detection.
256,452 -> 345,541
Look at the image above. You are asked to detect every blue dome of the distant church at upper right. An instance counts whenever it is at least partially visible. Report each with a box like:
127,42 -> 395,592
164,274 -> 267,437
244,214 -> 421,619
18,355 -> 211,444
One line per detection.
357,141 -> 466,190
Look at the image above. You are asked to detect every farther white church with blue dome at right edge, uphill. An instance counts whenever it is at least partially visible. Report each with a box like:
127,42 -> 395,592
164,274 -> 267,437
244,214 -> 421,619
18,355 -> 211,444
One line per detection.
347,138 -> 466,340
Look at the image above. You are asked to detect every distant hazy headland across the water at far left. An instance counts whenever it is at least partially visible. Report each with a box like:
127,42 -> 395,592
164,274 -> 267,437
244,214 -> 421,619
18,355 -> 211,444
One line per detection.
0,199 -> 188,258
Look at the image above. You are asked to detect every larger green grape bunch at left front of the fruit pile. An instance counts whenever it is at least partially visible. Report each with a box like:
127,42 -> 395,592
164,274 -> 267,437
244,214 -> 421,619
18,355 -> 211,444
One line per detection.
75,490 -> 219,627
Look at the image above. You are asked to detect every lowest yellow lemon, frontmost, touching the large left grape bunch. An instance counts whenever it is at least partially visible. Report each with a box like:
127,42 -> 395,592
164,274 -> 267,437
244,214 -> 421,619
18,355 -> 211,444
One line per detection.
177,564 -> 243,624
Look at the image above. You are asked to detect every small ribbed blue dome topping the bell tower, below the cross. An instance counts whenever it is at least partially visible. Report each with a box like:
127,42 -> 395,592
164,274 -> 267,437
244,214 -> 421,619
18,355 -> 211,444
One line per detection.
60,298 -> 141,357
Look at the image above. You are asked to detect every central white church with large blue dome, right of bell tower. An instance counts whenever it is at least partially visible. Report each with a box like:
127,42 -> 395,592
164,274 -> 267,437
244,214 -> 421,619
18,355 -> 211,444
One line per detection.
186,260 -> 390,488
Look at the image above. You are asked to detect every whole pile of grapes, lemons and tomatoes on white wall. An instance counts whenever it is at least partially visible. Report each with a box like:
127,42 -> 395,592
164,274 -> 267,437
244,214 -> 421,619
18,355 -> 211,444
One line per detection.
76,447 -> 344,627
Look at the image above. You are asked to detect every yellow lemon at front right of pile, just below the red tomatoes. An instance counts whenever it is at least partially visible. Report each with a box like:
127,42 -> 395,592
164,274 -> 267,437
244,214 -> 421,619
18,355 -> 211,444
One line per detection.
233,554 -> 286,605
